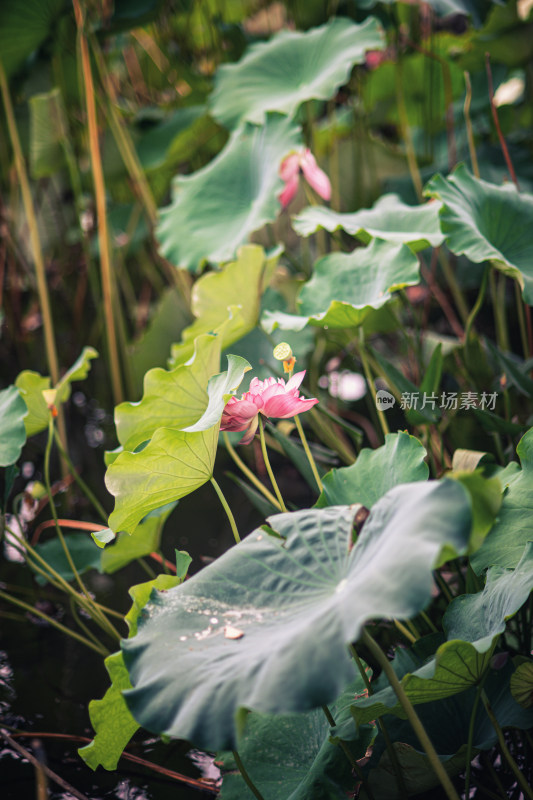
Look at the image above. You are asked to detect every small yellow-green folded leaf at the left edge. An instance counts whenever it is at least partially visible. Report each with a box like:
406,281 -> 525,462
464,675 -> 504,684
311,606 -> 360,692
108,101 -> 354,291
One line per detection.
15,347 -> 98,436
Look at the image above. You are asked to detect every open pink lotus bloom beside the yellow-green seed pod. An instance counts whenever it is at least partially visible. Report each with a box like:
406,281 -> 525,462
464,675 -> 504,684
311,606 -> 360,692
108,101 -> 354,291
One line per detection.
220,370 -> 318,444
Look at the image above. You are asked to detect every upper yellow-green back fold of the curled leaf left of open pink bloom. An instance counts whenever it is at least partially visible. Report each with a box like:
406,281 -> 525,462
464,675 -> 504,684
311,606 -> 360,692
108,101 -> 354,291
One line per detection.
115,334 -> 221,451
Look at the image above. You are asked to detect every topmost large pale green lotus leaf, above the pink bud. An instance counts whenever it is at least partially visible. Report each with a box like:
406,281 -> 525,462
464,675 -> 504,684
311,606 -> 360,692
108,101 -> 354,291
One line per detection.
209,18 -> 383,128
